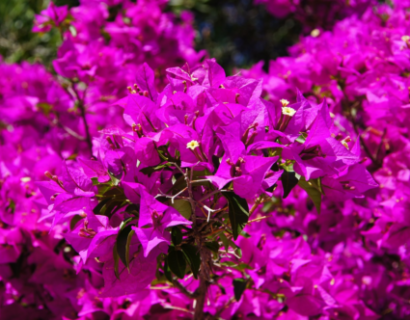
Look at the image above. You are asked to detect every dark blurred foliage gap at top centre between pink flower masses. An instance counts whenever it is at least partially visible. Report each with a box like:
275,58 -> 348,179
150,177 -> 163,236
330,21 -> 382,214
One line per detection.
169,0 -> 301,73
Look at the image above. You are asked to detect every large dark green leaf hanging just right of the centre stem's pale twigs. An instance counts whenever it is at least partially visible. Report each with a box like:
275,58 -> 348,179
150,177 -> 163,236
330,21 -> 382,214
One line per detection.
222,191 -> 249,240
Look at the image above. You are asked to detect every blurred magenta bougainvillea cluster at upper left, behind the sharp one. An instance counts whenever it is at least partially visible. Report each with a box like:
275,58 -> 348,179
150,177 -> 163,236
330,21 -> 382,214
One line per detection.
33,0 -> 205,158
